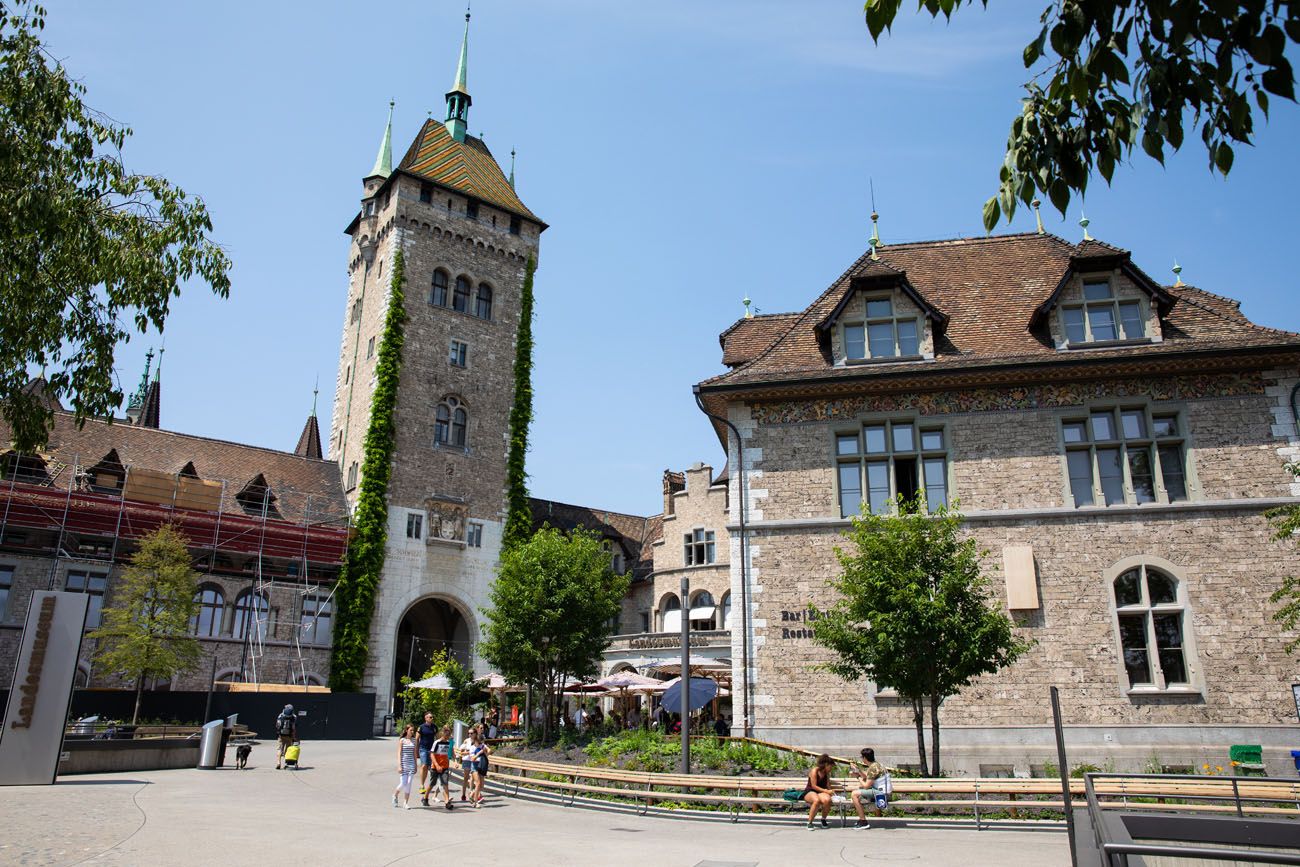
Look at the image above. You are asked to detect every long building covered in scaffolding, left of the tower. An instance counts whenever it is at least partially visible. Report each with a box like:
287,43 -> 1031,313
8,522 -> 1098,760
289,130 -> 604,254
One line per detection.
0,382 -> 348,690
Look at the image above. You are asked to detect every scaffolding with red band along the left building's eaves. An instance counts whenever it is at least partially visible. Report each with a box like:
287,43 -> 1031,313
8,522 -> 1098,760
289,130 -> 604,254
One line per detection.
0,452 -> 351,685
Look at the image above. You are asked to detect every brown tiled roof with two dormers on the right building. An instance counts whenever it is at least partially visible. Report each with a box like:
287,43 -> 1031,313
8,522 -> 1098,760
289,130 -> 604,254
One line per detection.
702,233 -> 1300,387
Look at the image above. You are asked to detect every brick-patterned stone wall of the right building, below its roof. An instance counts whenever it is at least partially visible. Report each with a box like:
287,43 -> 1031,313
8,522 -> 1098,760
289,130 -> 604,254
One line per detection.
731,370 -> 1296,731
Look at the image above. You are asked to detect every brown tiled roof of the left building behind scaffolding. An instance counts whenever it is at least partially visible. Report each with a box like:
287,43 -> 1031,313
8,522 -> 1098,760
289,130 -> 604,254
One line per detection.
0,412 -> 347,524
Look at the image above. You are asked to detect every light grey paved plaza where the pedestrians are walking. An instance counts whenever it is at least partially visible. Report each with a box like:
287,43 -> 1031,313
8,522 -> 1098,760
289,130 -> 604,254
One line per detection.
0,740 -> 1069,867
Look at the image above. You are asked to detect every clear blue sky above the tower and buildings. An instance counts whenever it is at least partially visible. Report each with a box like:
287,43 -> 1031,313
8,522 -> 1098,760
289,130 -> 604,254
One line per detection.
38,0 -> 1300,515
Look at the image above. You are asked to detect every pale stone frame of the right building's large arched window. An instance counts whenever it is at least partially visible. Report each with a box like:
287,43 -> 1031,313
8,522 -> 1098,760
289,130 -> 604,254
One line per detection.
1102,554 -> 1205,695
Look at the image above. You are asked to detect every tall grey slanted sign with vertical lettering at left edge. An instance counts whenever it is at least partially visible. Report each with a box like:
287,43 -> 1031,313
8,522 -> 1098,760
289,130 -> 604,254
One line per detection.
0,590 -> 90,785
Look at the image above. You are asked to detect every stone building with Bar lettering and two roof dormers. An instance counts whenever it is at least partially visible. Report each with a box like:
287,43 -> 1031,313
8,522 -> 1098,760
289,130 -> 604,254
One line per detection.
697,228 -> 1300,770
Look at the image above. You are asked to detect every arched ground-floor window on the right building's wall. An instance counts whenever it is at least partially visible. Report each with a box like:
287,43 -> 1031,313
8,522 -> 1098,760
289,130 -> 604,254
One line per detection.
1114,563 -> 1191,689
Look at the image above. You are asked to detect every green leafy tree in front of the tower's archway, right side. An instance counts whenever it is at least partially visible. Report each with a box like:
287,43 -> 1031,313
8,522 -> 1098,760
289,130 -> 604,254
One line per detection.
478,526 -> 628,738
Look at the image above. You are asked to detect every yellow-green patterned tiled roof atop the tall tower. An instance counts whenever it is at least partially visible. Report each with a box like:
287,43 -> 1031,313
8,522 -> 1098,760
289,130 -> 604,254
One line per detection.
398,120 -> 541,222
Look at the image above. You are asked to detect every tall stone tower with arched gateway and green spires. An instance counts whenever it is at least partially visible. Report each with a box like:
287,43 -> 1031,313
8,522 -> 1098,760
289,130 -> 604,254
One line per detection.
329,14 -> 546,715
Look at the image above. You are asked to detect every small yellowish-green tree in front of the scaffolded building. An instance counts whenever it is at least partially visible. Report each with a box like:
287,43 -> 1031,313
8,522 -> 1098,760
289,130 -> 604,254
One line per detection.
90,525 -> 200,724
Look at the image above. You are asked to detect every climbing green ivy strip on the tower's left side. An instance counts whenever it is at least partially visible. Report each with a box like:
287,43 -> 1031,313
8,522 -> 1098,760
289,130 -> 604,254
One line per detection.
329,250 -> 407,692
